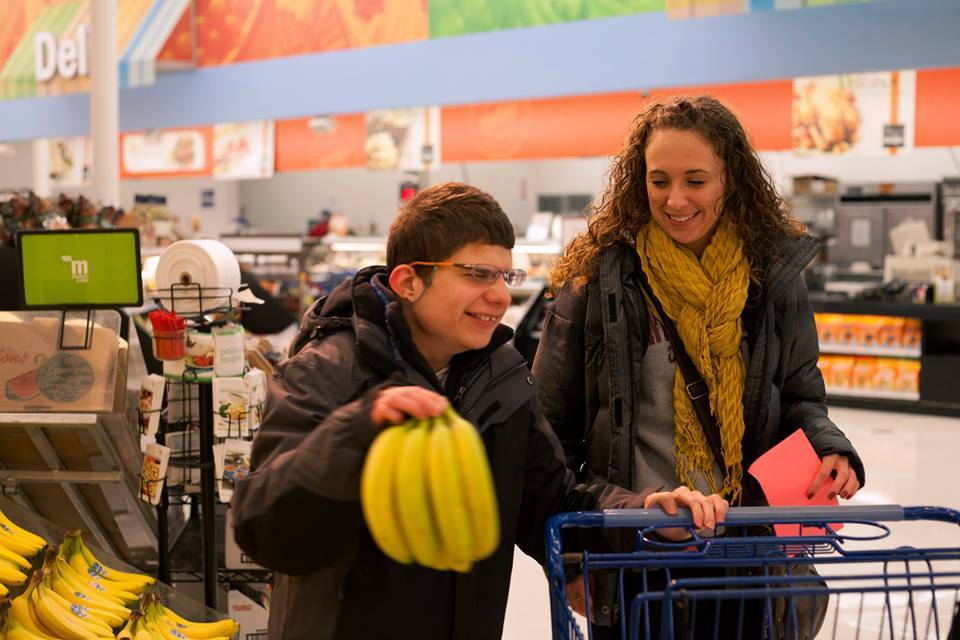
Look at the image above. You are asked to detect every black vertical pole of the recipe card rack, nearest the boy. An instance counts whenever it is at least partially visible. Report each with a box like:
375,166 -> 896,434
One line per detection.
198,383 -> 218,609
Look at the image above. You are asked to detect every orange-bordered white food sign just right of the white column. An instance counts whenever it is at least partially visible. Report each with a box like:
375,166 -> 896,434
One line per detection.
120,127 -> 213,179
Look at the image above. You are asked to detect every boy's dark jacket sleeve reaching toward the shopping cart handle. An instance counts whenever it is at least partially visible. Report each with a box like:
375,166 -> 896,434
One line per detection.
517,399 -> 650,565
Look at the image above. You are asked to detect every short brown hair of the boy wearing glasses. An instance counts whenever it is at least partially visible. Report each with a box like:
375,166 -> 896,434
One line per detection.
387,182 -> 515,271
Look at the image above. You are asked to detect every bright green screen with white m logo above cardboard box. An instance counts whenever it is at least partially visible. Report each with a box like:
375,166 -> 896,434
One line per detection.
17,229 -> 143,309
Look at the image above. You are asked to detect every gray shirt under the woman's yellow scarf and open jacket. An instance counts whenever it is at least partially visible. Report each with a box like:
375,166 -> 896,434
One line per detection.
632,304 -> 723,495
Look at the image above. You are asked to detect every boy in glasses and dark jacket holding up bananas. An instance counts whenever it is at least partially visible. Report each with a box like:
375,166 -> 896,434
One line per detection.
233,183 -> 642,640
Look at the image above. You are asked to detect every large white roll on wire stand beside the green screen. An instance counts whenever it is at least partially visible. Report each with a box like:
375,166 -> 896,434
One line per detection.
156,240 -> 240,315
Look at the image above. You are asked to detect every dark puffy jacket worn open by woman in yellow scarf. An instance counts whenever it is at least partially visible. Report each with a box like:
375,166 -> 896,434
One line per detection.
533,236 -> 864,490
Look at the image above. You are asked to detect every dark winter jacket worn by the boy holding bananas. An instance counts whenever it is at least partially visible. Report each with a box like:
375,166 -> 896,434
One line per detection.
232,268 -> 642,640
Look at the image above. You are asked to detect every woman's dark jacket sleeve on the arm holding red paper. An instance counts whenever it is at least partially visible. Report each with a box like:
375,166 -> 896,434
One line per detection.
779,276 -> 866,486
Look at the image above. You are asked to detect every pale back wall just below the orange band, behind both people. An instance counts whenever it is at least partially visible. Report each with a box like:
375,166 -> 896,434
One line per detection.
238,148 -> 960,234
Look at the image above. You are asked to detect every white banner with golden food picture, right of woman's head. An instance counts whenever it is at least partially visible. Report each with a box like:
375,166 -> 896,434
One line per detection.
792,71 -> 917,156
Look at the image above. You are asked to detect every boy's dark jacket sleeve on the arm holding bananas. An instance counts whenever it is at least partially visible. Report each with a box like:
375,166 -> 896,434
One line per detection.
232,343 -> 380,575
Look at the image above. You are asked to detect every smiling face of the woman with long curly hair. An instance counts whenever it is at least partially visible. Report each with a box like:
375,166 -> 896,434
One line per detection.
645,129 -> 724,257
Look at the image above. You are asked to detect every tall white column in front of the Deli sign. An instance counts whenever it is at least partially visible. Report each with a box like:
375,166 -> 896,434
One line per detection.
87,0 -> 120,206
